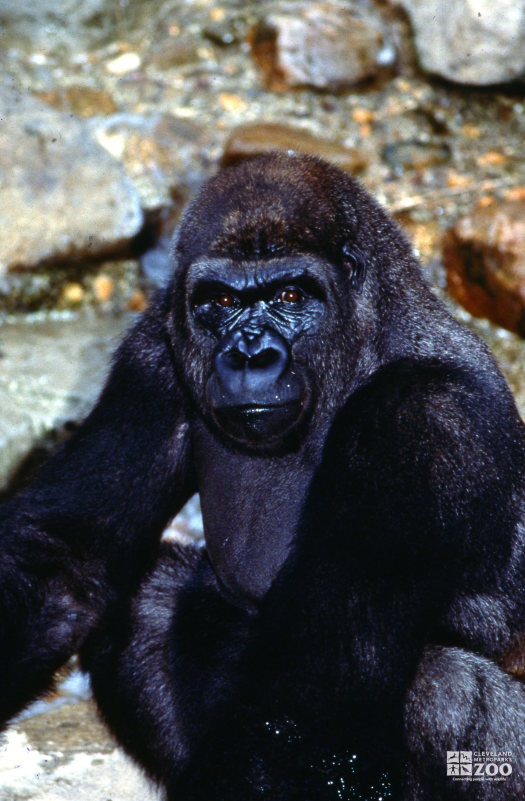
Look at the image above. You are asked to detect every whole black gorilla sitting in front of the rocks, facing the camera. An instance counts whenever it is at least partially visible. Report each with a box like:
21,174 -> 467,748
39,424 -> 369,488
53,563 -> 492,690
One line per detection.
0,154 -> 525,801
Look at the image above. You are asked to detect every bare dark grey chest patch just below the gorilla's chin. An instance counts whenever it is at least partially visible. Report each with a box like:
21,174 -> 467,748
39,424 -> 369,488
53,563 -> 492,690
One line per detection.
191,422 -> 315,601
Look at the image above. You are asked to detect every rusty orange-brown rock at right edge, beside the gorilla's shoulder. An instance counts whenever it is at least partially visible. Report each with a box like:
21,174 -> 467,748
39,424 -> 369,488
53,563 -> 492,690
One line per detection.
443,200 -> 525,337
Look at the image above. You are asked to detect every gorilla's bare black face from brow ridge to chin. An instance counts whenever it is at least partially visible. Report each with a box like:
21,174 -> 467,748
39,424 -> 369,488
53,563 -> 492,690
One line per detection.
186,255 -> 327,449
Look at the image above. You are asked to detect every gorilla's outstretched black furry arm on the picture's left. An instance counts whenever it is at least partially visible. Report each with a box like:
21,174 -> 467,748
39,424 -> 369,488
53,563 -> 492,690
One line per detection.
0,290 -> 194,723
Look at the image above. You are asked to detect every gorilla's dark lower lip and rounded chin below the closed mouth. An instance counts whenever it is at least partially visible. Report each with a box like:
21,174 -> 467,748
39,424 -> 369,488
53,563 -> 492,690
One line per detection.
214,398 -> 304,445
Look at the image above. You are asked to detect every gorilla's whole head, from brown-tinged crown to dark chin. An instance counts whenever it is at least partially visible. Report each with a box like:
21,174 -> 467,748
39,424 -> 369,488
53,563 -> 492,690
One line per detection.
171,149 -> 407,451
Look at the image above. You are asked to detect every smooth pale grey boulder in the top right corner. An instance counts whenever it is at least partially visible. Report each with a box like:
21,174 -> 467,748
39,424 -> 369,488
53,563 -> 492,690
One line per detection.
400,0 -> 525,86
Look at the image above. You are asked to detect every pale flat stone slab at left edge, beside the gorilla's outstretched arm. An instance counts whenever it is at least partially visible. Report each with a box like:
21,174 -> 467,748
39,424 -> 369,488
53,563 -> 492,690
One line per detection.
0,315 -> 129,492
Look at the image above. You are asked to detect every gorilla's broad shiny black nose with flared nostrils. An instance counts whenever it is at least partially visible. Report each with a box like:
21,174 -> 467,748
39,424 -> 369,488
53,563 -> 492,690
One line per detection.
215,331 -> 290,389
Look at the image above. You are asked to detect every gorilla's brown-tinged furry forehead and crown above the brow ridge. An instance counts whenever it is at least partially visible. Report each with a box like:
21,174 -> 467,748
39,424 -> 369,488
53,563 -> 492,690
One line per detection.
172,153 -> 363,269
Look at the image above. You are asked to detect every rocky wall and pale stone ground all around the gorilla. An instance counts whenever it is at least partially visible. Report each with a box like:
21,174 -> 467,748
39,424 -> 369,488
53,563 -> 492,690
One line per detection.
0,0 -> 525,801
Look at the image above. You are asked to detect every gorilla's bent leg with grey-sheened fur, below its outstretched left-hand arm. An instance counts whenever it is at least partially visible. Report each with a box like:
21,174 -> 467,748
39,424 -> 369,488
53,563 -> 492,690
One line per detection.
81,542 -> 257,798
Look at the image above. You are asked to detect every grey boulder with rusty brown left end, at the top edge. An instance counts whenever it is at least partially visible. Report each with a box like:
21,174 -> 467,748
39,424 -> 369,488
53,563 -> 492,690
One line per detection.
250,2 -> 395,91
